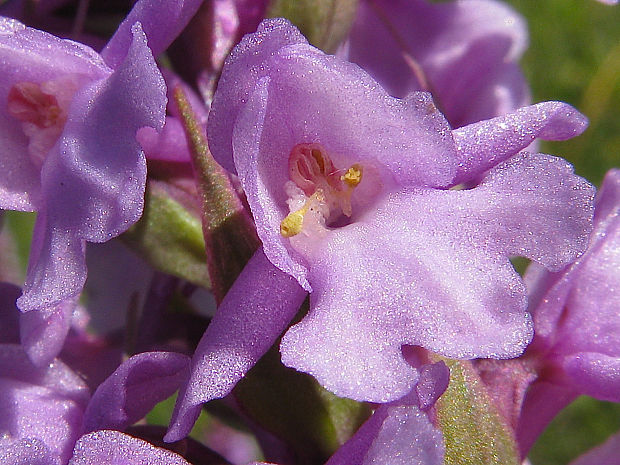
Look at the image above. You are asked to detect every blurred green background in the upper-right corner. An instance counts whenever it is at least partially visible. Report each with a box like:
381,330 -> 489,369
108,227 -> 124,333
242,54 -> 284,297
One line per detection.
508,0 -> 620,185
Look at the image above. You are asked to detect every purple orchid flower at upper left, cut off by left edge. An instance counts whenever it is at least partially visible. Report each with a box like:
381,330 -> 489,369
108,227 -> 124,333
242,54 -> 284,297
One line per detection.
0,0 -> 200,365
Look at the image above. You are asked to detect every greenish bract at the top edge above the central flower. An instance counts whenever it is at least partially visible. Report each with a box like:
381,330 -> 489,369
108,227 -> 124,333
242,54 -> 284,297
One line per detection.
267,0 -> 359,53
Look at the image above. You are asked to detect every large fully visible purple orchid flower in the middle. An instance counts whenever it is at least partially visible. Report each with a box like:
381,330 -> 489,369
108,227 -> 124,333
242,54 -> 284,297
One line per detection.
166,19 -> 593,440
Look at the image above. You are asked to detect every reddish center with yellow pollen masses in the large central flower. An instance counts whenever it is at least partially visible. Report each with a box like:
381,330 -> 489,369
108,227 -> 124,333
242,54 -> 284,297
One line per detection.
280,143 -> 363,237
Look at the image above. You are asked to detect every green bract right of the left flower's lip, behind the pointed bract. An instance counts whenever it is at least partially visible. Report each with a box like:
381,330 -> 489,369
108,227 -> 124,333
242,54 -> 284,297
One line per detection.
120,181 -> 211,288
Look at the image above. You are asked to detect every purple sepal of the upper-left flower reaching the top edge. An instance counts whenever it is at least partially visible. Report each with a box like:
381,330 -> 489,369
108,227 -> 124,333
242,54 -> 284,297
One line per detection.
101,0 -> 202,68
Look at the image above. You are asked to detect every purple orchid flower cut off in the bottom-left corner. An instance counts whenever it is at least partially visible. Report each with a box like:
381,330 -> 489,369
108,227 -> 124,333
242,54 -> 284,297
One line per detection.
0,283 -> 194,465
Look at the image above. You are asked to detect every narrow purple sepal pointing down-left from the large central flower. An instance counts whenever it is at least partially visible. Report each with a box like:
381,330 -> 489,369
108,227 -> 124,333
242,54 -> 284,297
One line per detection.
164,245 -> 306,441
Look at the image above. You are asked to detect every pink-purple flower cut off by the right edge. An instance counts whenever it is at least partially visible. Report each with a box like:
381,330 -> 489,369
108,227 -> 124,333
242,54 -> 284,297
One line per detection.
517,169 -> 620,455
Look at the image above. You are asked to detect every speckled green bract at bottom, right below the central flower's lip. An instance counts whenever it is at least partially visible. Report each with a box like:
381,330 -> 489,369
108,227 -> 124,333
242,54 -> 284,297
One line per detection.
436,359 -> 521,465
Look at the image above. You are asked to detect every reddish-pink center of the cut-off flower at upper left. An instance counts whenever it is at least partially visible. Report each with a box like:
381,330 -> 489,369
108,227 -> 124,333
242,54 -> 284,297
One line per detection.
7,76 -> 78,168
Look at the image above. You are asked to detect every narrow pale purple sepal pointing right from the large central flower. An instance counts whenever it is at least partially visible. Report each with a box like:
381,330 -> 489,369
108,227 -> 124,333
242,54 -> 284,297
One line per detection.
453,102 -> 588,184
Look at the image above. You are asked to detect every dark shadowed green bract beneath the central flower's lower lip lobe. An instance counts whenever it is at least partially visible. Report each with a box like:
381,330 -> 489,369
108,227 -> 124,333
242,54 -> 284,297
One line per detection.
234,343 -> 370,465
